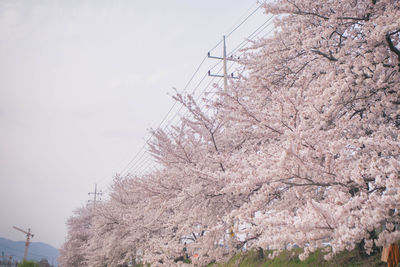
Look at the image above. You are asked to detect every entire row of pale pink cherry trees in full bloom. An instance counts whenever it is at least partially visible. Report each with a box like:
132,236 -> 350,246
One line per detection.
60,0 -> 400,266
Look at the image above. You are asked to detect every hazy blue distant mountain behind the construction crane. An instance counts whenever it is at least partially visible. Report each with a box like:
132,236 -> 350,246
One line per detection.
0,237 -> 59,266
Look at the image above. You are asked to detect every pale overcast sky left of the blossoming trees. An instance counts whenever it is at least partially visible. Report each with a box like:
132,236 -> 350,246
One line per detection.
0,0 -> 266,251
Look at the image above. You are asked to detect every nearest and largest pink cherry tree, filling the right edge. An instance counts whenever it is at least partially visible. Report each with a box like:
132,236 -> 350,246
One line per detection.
225,1 -> 400,258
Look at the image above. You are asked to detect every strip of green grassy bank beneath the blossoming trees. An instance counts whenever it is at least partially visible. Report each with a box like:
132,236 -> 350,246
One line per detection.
207,248 -> 387,267
